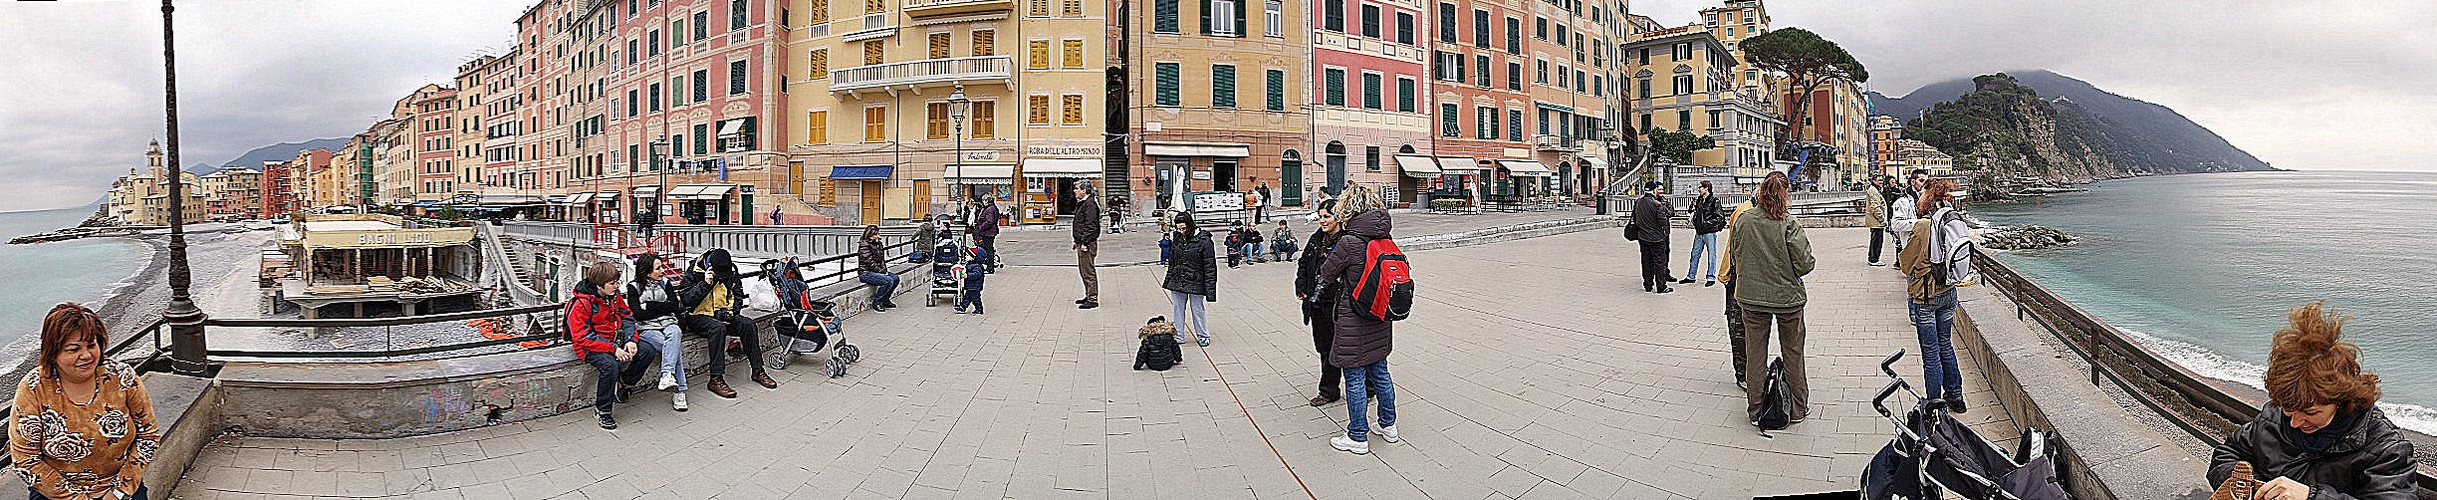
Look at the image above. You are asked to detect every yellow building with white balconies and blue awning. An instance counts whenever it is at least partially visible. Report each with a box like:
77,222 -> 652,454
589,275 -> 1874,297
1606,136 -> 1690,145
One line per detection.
780,0 -> 1109,224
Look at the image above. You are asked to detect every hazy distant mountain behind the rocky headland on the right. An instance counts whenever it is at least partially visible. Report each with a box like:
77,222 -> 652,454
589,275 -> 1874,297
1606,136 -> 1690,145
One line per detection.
1869,71 -> 2274,173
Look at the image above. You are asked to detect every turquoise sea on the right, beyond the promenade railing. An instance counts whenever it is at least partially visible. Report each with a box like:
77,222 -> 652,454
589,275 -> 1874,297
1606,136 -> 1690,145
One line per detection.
1972,171 -> 2437,432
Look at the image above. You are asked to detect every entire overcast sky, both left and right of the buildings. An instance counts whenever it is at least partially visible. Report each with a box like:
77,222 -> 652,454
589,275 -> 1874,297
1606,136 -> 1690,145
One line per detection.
0,0 -> 2437,212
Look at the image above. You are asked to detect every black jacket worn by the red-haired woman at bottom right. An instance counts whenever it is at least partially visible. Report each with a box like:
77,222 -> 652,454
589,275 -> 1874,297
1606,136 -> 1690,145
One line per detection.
2208,405 -> 2420,500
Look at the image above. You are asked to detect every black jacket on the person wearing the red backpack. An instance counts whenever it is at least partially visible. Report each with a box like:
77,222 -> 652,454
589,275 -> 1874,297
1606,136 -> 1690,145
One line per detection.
1321,210 -> 1396,368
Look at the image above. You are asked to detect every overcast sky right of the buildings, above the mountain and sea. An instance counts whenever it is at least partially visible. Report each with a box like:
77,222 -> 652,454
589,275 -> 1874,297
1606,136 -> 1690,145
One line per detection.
1633,0 -> 2437,171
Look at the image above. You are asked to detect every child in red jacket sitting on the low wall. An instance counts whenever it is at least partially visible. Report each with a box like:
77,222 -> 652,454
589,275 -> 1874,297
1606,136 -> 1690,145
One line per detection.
568,261 -> 660,429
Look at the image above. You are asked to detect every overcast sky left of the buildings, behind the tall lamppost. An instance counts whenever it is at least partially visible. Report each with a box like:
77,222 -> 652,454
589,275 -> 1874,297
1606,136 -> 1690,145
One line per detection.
0,0 -> 529,212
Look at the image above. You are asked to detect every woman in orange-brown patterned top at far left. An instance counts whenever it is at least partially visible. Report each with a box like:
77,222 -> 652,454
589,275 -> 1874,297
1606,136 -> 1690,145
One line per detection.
7,302 -> 161,500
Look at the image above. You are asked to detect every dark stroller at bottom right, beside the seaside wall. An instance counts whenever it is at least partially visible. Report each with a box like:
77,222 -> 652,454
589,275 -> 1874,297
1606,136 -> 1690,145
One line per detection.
1862,349 -> 2071,500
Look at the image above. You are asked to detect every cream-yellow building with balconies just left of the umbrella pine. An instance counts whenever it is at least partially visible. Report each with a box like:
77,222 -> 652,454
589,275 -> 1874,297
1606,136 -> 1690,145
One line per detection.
1621,29 -> 1784,176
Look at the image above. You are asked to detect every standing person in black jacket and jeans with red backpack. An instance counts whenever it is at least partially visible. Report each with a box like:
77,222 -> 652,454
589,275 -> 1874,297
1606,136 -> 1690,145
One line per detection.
1321,183 -> 1399,454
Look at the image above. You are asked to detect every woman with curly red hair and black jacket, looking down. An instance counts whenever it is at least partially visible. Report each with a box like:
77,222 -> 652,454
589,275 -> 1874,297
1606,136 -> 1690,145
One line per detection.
2208,302 -> 2418,500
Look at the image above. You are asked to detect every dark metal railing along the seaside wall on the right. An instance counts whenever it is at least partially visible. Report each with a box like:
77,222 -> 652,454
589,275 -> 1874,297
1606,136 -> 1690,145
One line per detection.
1972,249 -> 2437,490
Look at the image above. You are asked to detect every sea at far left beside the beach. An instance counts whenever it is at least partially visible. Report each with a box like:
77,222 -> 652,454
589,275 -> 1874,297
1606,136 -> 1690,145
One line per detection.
0,207 -> 151,346
